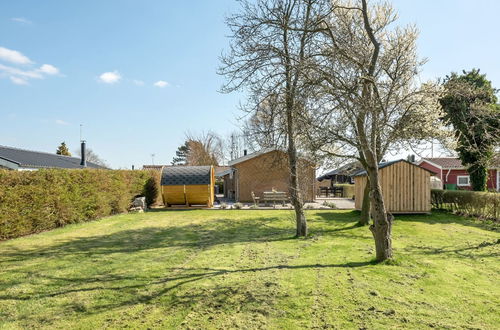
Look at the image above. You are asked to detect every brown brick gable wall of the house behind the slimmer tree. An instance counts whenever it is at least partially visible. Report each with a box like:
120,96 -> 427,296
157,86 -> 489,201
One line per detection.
233,151 -> 316,202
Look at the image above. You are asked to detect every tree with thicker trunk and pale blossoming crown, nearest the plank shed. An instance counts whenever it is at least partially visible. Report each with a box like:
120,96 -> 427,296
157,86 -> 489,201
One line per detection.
304,0 -> 442,260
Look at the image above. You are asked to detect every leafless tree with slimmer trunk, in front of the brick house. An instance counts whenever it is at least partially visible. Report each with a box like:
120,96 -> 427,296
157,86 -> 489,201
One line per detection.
219,0 -> 326,236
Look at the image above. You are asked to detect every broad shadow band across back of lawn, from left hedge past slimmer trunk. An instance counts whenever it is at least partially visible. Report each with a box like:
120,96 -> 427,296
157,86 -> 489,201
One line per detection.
0,213 -> 366,264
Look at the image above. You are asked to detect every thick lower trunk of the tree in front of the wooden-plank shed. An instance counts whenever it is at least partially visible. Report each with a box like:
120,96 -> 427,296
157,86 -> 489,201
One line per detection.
367,167 -> 393,261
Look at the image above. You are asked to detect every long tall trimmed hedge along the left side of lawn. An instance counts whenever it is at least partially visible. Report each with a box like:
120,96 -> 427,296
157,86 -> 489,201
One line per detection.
0,169 -> 155,240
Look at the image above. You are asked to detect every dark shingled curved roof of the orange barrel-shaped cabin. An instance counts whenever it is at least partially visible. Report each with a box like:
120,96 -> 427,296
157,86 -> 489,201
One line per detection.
161,166 -> 212,186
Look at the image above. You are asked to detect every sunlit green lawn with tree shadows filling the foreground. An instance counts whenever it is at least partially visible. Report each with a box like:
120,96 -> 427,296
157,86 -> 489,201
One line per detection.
0,210 -> 500,329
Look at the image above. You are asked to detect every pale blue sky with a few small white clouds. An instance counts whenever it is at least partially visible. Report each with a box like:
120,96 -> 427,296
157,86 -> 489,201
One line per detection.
0,0 -> 500,168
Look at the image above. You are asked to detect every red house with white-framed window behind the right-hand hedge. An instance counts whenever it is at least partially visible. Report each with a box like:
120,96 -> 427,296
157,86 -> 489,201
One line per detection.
417,157 -> 500,191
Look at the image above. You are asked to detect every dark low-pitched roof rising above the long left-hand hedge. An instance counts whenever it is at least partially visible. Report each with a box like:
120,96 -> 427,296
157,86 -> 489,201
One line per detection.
0,146 -> 105,168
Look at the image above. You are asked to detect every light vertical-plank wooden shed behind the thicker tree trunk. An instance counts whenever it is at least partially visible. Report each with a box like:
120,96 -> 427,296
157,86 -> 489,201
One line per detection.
354,159 -> 435,213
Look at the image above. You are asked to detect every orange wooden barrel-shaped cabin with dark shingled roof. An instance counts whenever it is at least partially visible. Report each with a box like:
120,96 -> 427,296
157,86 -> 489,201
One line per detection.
161,166 -> 215,207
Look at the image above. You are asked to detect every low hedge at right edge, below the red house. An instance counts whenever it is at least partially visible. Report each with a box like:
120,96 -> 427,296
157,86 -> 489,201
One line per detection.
431,189 -> 500,220
